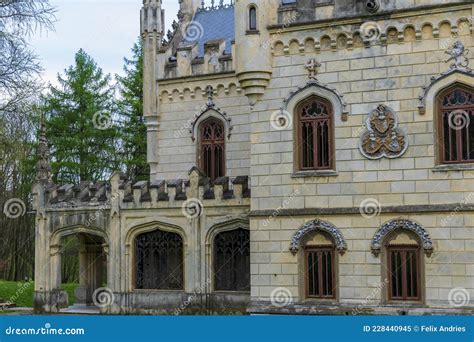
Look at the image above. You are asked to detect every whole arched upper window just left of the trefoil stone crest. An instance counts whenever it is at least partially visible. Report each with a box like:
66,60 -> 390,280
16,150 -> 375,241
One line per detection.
296,96 -> 334,171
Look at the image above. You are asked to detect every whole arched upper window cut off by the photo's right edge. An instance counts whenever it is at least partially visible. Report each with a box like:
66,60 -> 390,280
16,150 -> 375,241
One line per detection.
438,86 -> 474,164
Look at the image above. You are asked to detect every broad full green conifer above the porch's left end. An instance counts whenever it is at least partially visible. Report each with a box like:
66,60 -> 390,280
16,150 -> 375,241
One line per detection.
43,49 -> 120,184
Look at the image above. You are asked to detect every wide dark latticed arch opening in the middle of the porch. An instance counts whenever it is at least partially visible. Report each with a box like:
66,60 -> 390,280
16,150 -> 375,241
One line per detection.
135,230 -> 184,290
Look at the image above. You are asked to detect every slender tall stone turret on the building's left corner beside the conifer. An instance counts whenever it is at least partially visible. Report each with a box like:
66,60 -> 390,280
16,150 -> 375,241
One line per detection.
141,0 -> 164,179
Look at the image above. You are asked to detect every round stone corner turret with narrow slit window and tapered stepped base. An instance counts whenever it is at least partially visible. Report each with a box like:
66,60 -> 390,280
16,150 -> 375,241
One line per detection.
235,0 -> 275,106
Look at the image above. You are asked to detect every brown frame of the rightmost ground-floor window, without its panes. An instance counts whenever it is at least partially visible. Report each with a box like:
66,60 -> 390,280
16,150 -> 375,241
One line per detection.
386,245 -> 422,302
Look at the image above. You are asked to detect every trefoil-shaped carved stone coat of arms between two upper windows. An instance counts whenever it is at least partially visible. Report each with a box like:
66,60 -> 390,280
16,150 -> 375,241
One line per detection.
359,105 -> 408,160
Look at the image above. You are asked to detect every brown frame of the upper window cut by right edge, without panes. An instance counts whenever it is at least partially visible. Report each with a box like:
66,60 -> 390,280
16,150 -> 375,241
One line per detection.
436,84 -> 474,164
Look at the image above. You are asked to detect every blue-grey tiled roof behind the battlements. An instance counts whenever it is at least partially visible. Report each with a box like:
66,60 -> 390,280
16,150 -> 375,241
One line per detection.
186,6 -> 235,57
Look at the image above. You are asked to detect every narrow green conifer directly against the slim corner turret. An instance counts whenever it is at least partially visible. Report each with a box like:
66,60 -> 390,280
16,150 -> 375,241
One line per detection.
116,39 -> 149,180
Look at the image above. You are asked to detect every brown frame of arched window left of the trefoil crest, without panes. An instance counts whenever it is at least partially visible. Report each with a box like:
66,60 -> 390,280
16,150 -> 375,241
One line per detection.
295,96 -> 335,171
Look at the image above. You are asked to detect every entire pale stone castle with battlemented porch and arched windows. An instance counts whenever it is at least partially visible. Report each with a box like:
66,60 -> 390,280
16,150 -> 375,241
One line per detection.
34,0 -> 474,314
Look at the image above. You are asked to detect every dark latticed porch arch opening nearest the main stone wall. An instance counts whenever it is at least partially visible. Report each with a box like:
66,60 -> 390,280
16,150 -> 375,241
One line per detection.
214,228 -> 250,291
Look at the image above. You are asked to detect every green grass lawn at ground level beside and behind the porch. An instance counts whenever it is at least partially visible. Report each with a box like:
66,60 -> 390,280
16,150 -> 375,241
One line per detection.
0,280 -> 78,307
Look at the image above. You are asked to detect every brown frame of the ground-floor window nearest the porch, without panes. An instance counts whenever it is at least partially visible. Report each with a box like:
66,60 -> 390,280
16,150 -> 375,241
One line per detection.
304,245 -> 337,299
